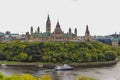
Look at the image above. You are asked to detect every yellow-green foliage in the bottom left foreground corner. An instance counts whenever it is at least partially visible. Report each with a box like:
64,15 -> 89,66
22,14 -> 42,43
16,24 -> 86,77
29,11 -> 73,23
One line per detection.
0,73 -> 52,80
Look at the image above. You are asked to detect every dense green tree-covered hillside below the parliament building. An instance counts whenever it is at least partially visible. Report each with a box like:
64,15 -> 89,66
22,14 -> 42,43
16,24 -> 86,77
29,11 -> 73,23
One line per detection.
0,41 -> 120,63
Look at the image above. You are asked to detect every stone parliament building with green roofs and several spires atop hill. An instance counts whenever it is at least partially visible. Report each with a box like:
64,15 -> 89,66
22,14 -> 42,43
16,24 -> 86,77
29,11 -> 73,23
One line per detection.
26,15 -> 77,42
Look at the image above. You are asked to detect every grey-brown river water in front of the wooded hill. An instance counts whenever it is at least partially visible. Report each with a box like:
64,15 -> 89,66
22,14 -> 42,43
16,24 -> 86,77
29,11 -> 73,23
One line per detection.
0,62 -> 120,80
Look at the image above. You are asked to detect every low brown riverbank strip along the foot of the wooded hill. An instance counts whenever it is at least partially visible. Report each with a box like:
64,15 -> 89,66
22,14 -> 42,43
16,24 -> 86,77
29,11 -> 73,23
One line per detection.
0,60 -> 119,70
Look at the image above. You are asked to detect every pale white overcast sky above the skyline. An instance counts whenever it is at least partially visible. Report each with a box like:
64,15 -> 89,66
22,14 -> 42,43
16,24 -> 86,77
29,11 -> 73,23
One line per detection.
0,0 -> 120,36
